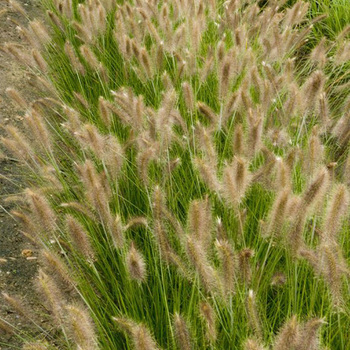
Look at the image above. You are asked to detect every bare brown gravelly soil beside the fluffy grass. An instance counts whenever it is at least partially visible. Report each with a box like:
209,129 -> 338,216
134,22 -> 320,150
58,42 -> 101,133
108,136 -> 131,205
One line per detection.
0,0 -> 44,350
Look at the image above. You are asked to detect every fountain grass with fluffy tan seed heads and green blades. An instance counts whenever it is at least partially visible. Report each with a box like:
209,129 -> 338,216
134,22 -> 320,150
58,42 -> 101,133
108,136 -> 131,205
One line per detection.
2,0 -> 350,350
